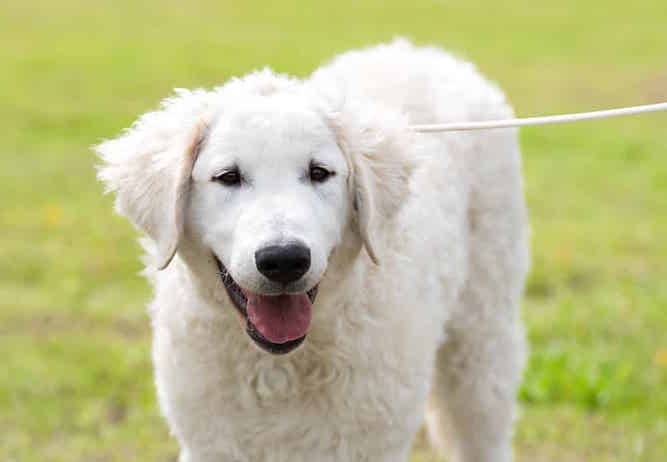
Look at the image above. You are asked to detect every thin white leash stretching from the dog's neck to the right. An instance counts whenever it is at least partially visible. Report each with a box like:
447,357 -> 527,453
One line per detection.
410,102 -> 667,133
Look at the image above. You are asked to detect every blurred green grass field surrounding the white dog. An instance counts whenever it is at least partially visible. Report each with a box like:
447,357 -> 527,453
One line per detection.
0,0 -> 667,462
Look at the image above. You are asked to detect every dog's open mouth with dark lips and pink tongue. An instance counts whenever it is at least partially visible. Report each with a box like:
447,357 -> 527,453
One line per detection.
214,255 -> 318,355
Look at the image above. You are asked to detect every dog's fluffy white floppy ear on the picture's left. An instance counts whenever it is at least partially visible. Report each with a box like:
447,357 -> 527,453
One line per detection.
94,91 -> 207,269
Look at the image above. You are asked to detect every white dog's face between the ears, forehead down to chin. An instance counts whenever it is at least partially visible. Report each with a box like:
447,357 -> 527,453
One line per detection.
186,99 -> 351,353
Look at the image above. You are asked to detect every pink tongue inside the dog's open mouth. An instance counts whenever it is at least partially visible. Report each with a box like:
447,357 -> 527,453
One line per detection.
243,291 -> 313,343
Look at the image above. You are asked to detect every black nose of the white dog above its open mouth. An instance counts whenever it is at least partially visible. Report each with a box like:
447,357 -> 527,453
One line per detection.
255,244 -> 310,284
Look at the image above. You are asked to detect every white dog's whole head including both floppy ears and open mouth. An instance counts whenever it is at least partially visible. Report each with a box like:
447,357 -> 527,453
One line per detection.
96,71 -> 412,353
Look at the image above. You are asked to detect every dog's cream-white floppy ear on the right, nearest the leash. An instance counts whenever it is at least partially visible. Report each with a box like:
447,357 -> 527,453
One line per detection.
330,107 -> 415,264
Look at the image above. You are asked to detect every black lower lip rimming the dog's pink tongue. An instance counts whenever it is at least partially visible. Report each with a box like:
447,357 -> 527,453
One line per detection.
213,254 -> 318,355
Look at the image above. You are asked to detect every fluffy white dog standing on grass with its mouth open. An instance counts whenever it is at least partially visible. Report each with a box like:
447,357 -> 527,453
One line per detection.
96,40 -> 528,462
